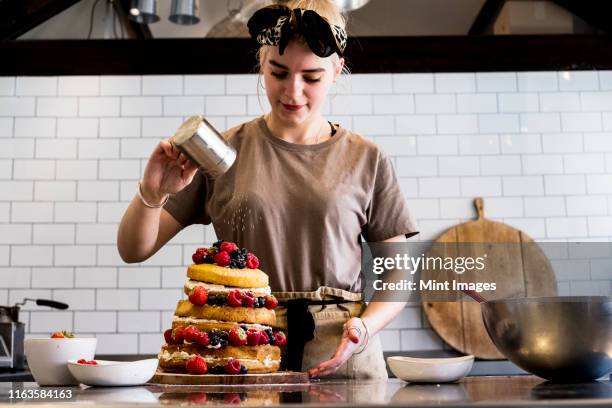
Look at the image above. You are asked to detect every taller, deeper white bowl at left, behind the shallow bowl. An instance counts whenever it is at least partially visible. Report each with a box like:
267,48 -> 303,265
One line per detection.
24,337 -> 98,385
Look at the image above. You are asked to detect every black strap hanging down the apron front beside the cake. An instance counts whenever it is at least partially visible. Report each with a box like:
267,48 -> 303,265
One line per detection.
287,299 -> 315,371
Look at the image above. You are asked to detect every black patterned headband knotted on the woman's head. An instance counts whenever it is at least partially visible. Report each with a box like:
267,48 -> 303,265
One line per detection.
247,5 -> 347,58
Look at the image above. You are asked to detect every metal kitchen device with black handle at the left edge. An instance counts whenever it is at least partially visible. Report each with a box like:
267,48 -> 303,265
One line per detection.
0,298 -> 68,370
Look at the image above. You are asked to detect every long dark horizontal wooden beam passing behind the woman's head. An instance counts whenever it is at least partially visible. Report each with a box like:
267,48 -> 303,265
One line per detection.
0,34 -> 612,76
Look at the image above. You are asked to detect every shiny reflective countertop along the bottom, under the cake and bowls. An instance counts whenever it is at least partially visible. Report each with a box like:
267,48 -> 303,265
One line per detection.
0,376 -> 612,408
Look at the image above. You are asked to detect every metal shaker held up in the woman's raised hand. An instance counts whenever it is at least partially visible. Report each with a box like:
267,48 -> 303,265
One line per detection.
170,115 -> 236,178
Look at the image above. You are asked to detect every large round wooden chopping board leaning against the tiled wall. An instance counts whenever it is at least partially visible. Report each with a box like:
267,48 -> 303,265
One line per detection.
421,198 -> 557,360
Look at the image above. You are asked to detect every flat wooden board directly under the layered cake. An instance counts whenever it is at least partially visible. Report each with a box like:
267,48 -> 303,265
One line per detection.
149,370 -> 308,385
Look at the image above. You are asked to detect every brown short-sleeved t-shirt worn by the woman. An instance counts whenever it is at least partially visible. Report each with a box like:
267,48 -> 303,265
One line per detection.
164,117 -> 417,292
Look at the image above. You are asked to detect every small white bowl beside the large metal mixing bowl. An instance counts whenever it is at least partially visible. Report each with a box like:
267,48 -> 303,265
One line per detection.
387,355 -> 474,383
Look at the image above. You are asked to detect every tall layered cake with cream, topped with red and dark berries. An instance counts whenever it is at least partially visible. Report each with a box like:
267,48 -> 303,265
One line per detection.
159,241 -> 287,374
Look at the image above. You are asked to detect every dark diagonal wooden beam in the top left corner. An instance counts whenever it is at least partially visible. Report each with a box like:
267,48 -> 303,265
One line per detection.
0,0 -> 81,40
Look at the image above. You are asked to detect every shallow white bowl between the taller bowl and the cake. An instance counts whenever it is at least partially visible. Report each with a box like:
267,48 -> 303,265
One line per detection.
68,358 -> 158,386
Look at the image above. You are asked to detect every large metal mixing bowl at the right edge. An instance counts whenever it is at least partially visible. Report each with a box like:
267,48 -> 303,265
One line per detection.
480,296 -> 612,382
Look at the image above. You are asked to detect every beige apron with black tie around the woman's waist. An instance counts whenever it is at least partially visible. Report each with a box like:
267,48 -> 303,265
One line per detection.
274,286 -> 388,380
